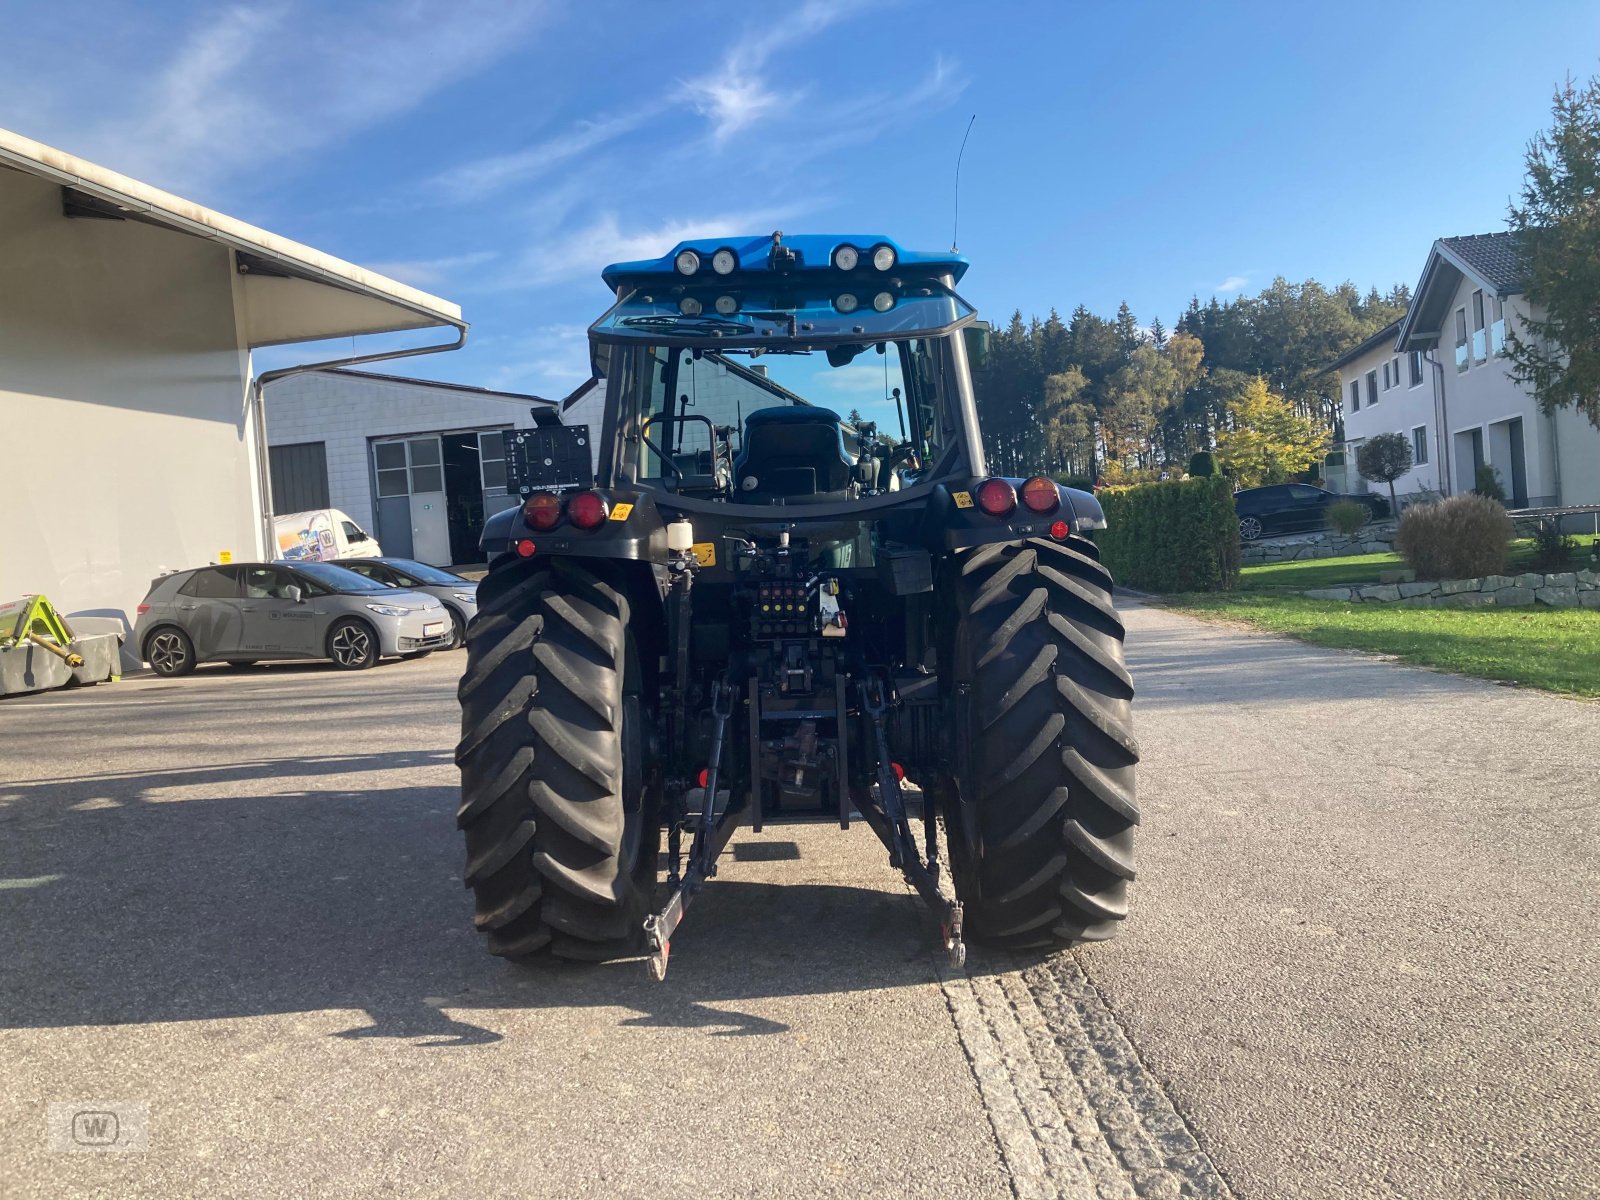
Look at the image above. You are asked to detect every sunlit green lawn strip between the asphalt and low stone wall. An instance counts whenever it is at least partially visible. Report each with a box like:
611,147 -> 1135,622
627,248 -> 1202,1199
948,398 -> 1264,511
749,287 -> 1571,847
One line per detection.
1162,588 -> 1600,698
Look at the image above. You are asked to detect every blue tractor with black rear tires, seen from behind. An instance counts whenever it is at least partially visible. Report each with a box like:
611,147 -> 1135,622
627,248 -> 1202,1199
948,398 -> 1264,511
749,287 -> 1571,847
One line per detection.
456,234 -> 1139,979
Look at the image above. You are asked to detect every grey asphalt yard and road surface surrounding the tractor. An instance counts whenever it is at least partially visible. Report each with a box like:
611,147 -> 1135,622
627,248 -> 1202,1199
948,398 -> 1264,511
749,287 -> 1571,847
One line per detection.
0,606 -> 1600,1200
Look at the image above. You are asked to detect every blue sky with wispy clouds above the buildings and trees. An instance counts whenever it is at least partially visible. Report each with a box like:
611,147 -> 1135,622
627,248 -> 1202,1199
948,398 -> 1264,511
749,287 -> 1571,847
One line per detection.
0,0 -> 1600,395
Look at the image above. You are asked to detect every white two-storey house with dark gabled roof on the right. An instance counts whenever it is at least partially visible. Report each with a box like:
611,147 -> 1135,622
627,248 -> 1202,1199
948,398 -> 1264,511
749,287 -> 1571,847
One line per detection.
1334,234 -> 1600,509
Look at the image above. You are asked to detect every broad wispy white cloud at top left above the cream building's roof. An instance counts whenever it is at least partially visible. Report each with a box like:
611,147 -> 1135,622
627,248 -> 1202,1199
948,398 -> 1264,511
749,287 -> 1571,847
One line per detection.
58,0 -> 544,190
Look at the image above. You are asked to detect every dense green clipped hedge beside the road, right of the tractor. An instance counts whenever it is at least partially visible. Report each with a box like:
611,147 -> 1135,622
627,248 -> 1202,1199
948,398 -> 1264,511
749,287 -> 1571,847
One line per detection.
1094,475 -> 1238,592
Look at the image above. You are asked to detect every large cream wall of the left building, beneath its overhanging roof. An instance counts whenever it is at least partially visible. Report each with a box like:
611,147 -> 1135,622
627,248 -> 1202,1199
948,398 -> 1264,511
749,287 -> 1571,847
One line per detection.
0,171 -> 261,659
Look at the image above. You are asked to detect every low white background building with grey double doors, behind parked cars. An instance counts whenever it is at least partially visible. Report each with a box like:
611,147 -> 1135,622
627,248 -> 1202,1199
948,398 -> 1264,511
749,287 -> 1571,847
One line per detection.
266,370 -> 605,566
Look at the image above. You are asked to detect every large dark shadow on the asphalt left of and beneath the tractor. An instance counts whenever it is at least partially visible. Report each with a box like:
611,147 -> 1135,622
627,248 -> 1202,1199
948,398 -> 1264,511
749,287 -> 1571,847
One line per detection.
0,750 -> 933,1046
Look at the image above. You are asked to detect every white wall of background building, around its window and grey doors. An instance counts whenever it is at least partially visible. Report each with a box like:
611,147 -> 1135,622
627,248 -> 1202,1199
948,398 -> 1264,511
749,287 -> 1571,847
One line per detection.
266,371 -> 550,531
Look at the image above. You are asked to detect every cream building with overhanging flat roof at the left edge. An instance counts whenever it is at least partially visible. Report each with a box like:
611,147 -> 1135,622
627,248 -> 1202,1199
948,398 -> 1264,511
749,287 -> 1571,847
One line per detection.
0,130 -> 466,666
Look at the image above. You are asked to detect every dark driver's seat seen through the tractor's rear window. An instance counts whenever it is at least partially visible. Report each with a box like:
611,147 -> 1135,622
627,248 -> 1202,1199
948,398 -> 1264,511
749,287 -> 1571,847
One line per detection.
733,405 -> 856,504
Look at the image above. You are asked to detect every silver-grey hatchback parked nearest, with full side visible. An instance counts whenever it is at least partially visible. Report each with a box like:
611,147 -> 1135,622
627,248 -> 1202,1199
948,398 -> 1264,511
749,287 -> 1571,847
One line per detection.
133,563 -> 453,675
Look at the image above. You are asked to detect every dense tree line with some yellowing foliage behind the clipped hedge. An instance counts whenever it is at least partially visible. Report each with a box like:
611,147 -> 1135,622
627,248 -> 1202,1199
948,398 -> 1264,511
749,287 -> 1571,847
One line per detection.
973,278 -> 1410,485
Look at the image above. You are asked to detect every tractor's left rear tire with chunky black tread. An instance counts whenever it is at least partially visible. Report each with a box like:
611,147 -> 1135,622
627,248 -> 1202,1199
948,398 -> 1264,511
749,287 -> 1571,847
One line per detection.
456,560 -> 659,960
